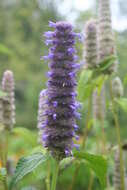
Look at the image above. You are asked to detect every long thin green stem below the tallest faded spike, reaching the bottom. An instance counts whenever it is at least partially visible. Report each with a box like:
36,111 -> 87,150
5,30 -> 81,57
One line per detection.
110,80 -> 125,190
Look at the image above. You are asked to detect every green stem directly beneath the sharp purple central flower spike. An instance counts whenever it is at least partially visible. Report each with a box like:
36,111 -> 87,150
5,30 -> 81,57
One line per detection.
51,161 -> 59,190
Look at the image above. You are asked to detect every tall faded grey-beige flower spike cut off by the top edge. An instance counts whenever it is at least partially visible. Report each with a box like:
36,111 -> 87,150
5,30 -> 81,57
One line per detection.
98,0 -> 118,73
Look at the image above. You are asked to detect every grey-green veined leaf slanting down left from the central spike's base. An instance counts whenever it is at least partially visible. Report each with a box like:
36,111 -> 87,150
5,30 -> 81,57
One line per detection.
9,152 -> 48,190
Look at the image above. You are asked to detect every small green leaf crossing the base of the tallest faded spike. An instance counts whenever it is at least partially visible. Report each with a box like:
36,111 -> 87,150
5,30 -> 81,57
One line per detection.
99,55 -> 117,71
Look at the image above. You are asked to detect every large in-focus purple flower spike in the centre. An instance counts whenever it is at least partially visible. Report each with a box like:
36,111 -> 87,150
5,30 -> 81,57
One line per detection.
42,22 -> 80,159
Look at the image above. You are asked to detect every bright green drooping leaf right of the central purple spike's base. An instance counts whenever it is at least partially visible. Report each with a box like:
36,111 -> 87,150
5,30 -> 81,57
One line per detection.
74,152 -> 107,189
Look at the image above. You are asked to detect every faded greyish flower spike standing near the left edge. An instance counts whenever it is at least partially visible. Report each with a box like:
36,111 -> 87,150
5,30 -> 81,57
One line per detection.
2,71 -> 15,129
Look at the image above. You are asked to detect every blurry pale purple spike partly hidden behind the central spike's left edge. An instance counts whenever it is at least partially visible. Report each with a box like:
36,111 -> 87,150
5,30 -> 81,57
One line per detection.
37,89 -> 47,143
